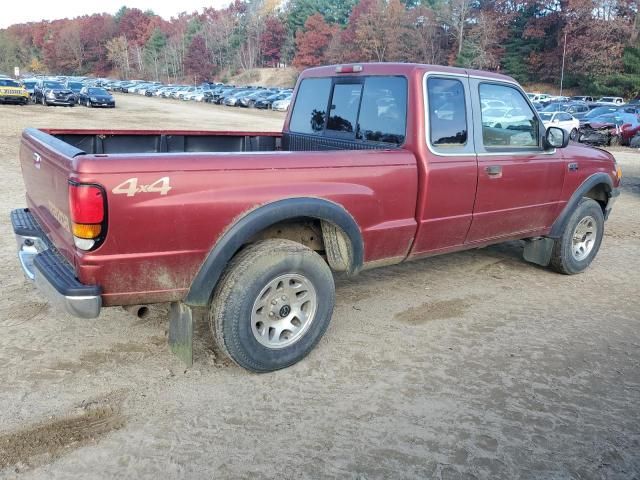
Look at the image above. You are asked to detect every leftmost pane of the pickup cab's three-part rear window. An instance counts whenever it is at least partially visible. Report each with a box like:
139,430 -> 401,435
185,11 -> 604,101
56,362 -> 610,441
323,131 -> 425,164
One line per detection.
290,78 -> 331,133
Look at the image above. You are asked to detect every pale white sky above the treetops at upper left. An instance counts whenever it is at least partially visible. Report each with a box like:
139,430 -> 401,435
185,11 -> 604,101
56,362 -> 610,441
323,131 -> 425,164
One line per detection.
0,0 -> 229,28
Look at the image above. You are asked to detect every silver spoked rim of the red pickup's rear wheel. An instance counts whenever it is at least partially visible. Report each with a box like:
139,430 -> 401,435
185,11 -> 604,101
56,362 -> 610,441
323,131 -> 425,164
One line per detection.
251,273 -> 318,349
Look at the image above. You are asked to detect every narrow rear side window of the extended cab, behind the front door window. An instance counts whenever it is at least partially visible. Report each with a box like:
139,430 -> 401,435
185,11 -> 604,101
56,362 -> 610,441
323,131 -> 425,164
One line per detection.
427,78 -> 467,147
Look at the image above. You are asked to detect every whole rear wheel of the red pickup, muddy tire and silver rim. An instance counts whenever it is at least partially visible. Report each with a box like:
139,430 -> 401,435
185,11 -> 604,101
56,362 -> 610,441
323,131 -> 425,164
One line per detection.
209,239 -> 335,372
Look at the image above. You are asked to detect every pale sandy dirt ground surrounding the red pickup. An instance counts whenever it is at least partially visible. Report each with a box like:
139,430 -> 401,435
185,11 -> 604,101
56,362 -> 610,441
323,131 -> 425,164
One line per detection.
0,95 -> 640,480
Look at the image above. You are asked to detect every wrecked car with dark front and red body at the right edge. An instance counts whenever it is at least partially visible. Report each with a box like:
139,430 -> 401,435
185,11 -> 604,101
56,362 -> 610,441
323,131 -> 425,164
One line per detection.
578,113 -> 640,146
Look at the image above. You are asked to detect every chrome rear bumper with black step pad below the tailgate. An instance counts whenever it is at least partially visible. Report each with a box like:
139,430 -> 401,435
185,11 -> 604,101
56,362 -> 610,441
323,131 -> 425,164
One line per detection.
11,208 -> 102,318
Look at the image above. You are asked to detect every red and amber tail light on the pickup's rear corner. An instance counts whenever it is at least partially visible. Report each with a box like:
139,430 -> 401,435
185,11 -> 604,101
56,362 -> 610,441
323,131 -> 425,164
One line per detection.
69,182 -> 106,250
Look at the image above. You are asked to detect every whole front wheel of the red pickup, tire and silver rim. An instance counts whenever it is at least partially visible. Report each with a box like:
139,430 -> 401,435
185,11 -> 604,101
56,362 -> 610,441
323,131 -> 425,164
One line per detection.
551,197 -> 604,275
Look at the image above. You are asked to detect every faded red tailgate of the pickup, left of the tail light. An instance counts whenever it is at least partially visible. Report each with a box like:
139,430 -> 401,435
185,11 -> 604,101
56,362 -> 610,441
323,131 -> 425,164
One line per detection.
20,128 -> 84,268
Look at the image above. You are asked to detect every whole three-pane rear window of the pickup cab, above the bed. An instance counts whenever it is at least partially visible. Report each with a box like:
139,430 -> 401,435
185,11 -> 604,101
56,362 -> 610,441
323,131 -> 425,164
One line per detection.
289,76 -> 407,145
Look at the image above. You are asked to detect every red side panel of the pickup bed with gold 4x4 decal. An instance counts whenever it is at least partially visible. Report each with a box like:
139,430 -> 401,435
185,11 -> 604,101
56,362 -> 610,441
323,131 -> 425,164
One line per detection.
73,150 -> 418,305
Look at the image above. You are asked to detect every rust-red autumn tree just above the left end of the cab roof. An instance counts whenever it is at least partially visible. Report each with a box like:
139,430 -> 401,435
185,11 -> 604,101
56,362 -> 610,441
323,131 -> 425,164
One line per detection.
293,13 -> 336,69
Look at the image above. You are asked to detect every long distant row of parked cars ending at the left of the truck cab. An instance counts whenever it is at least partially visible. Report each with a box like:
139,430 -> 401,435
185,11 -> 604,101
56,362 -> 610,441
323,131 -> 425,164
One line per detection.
101,80 -> 293,112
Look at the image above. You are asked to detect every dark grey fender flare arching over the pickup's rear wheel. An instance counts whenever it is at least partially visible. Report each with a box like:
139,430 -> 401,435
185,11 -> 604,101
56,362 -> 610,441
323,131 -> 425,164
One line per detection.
184,197 -> 364,307
